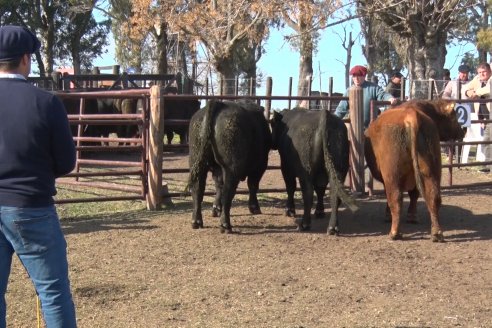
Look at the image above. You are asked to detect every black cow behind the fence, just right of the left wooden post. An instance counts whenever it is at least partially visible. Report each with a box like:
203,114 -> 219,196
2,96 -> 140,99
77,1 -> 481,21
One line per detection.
164,99 -> 200,145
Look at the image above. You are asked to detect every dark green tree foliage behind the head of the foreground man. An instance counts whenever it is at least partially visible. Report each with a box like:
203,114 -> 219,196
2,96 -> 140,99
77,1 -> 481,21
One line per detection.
0,0 -> 108,75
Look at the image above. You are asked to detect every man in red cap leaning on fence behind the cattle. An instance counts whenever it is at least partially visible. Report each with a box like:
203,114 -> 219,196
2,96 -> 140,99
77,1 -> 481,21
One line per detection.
335,65 -> 398,128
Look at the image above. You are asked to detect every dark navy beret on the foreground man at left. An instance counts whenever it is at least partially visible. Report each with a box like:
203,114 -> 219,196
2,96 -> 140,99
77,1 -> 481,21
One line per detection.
0,25 -> 41,61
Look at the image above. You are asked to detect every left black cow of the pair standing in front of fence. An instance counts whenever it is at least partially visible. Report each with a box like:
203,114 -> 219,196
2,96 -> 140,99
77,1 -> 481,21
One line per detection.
188,101 -> 271,233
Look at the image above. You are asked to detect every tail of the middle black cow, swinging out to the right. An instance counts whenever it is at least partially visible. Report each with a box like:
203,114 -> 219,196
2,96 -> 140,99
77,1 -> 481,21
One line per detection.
320,109 -> 359,212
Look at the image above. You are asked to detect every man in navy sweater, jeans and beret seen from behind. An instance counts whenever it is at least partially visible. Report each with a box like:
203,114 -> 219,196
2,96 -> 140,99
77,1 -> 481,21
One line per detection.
0,25 -> 77,328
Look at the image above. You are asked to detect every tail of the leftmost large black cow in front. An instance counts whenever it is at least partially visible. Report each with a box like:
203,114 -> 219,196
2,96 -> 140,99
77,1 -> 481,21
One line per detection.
186,100 -> 219,190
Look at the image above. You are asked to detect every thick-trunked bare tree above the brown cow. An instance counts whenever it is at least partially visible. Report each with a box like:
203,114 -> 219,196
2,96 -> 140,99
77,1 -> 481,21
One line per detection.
358,0 -> 476,89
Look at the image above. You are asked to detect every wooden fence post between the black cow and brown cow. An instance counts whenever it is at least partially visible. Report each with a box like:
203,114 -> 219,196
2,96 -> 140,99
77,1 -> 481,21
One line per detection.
349,86 -> 365,195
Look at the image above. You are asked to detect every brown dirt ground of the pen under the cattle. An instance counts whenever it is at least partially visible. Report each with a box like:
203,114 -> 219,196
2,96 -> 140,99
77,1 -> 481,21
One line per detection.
3,152 -> 492,328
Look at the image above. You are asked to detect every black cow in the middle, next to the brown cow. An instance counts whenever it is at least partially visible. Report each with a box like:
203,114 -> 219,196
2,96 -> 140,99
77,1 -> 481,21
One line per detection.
271,108 -> 357,234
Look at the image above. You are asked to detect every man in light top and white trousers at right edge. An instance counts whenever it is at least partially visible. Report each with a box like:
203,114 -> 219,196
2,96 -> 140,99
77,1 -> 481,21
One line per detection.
464,63 -> 492,173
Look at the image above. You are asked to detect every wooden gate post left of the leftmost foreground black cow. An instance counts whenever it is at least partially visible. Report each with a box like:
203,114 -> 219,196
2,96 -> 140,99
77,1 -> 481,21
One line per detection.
147,85 -> 164,211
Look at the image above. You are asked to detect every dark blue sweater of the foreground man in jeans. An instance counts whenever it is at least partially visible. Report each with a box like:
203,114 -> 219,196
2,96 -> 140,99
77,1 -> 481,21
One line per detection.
0,78 -> 75,207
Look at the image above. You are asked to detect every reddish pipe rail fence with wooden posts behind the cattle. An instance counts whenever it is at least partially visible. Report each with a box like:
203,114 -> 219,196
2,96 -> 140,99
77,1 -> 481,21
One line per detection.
36,86 -> 492,210
